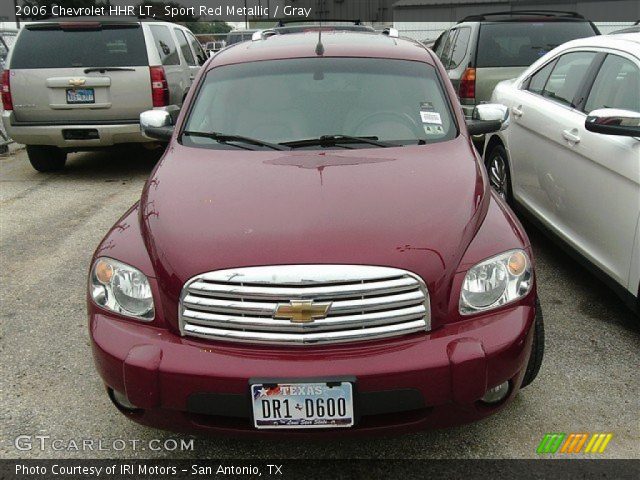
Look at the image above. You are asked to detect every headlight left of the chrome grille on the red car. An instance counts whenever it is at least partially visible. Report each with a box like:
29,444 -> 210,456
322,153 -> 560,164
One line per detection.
90,257 -> 154,320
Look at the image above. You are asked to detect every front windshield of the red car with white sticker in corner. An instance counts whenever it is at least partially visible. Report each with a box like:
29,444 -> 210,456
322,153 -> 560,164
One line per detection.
183,57 -> 457,148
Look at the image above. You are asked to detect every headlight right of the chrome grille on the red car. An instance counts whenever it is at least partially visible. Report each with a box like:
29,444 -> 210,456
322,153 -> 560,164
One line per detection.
459,250 -> 533,315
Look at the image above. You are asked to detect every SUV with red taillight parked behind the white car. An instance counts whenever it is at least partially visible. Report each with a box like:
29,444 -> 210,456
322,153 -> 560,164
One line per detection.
434,10 -> 599,116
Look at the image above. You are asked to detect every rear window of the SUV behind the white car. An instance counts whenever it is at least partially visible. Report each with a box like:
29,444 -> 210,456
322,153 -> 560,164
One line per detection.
476,21 -> 597,67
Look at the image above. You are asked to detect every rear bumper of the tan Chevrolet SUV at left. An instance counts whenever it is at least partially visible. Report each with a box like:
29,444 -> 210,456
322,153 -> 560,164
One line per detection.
2,111 -> 152,148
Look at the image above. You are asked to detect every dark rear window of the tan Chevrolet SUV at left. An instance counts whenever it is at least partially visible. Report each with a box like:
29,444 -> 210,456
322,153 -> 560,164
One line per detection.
11,24 -> 148,69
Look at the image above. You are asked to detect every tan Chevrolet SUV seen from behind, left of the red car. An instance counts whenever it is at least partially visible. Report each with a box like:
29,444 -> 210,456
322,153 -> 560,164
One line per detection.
2,17 -> 207,172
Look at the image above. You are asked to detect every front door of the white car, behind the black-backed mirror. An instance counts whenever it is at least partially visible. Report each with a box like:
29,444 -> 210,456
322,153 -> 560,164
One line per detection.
540,52 -> 640,286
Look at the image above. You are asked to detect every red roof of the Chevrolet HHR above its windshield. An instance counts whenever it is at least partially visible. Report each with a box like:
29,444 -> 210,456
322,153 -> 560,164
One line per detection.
209,30 -> 434,68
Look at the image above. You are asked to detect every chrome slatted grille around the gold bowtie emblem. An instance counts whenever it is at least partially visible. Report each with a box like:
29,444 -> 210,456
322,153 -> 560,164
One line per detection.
179,265 -> 430,345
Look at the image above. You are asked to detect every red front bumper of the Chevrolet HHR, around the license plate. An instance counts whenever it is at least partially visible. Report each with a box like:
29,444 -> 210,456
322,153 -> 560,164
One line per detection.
90,306 -> 535,436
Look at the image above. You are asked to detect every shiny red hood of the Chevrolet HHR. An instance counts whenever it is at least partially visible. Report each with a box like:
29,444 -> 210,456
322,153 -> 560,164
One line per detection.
140,136 -> 488,317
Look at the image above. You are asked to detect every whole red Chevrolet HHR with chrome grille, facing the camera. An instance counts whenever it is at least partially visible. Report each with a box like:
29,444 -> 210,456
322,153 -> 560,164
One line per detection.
88,29 -> 544,435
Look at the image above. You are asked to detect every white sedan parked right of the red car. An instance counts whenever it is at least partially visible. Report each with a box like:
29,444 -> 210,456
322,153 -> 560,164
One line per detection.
484,33 -> 640,312
